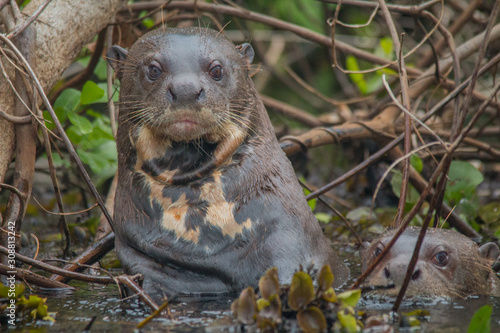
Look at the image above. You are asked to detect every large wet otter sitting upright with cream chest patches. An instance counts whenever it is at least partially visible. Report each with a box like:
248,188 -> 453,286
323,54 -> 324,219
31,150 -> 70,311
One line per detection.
107,28 -> 349,295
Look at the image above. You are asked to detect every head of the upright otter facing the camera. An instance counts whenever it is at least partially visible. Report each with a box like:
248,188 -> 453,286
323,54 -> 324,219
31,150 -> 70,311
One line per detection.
107,28 -> 254,142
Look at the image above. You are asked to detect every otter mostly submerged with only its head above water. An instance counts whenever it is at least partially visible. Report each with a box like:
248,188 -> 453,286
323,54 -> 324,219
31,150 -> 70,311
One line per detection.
361,227 -> 500,298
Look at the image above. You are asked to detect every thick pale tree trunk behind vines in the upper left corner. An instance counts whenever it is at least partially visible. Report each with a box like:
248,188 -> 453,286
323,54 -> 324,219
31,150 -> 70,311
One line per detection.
0,0 -> 123,182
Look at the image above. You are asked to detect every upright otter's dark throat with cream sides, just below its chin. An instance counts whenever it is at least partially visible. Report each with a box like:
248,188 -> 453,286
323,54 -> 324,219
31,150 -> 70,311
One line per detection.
130,125 -> 247,185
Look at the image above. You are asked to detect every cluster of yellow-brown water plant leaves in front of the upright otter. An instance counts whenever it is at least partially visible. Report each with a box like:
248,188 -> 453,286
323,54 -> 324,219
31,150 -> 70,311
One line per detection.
231,265 -> 364,332
